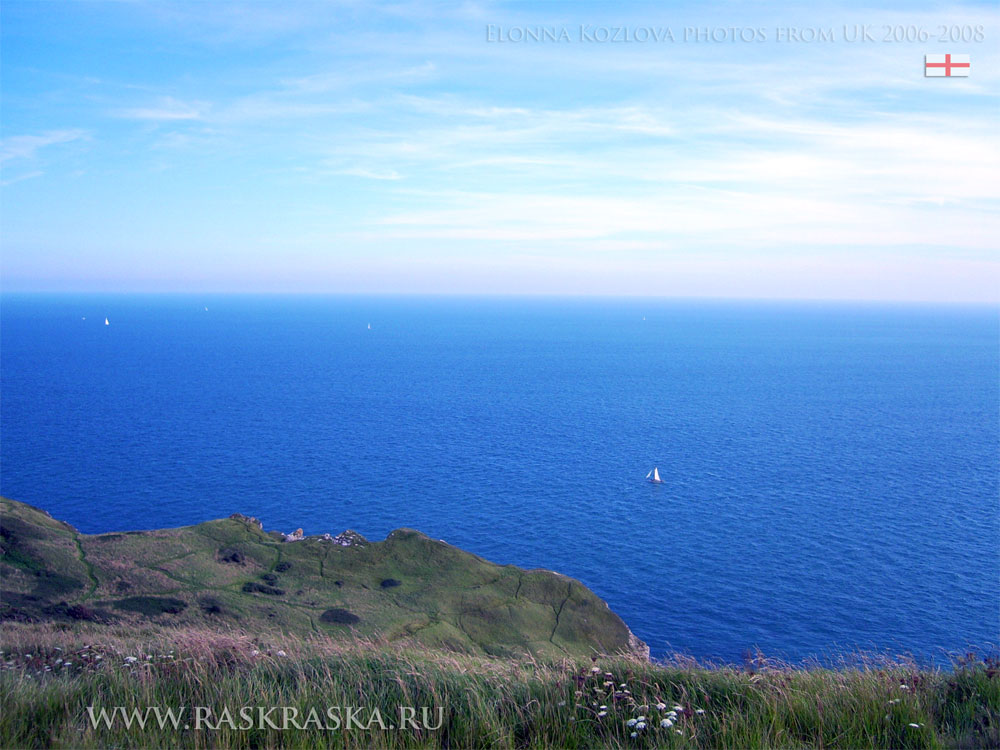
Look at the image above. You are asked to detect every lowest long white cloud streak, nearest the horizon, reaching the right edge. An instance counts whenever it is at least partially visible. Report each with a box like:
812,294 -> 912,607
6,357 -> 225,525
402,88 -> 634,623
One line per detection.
370,188 -> 1000,252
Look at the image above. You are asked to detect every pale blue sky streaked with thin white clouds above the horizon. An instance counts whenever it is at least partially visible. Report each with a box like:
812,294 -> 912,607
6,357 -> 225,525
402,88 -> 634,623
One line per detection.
0,0 -> 1000,302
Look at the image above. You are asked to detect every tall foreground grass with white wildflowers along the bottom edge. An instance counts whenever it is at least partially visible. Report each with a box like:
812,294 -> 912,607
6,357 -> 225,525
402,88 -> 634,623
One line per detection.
0,623 -> 1000,748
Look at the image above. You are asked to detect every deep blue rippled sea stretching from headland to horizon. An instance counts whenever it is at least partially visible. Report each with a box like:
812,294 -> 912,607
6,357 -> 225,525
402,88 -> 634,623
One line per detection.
0,295 -> 1000,661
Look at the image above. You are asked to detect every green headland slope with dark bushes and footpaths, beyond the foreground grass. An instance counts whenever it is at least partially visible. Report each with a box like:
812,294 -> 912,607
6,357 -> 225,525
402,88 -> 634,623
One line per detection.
0,499 -> 644,657
